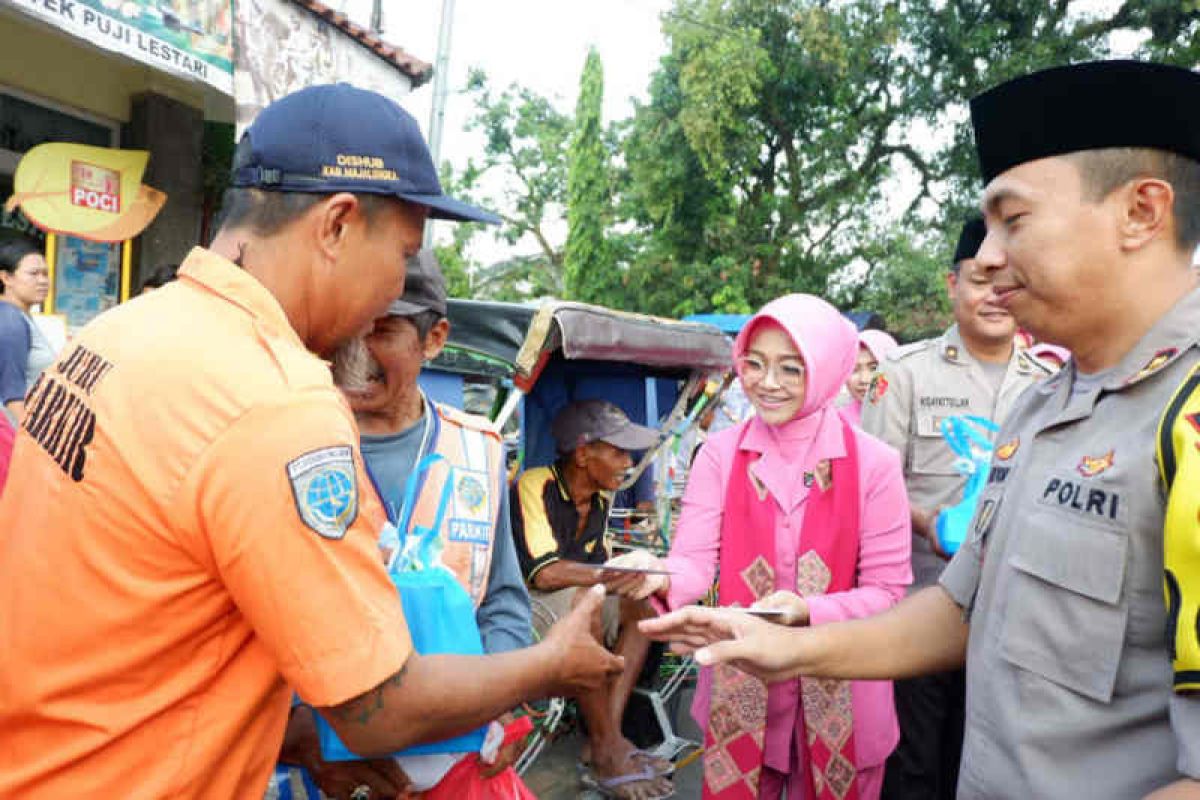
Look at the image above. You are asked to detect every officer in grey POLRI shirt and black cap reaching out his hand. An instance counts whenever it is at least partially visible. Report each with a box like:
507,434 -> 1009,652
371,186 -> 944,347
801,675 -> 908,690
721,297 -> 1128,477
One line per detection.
643,61 -> 1200,800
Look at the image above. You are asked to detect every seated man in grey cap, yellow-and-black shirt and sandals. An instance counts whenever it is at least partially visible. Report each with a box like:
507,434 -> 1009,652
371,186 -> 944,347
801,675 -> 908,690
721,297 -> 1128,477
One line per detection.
511,399 -> 672,800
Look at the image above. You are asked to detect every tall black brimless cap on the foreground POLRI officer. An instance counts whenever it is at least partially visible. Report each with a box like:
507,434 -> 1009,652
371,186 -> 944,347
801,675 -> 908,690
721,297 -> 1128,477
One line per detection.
971,61 -> 1200,184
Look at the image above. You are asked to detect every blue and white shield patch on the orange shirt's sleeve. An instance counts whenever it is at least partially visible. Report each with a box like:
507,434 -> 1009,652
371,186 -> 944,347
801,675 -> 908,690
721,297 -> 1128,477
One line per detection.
287,445 -> 359,539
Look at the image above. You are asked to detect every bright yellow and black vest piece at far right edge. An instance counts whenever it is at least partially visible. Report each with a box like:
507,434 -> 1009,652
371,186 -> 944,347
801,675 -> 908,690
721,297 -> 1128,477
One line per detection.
1158,367 -> 1200,692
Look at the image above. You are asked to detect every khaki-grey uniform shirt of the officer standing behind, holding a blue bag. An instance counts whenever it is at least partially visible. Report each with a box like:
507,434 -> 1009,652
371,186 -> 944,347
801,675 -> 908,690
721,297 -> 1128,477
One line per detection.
862,325 -> 1050,590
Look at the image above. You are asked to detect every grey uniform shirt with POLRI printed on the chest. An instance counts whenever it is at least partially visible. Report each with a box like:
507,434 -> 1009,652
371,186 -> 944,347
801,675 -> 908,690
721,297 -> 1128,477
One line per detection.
941,290 -> 1200,800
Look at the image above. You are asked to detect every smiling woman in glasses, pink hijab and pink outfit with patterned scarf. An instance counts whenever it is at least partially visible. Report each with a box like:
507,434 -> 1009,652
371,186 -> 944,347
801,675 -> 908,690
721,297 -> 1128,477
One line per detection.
614,295 -> 912,800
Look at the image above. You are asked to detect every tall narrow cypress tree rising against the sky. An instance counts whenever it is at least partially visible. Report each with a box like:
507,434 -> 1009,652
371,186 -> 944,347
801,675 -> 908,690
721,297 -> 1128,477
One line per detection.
563,47 -> 616,302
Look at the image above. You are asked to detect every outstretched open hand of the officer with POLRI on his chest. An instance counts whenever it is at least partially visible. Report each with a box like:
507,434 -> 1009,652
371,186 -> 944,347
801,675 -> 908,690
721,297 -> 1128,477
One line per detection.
638,606 -> 803,682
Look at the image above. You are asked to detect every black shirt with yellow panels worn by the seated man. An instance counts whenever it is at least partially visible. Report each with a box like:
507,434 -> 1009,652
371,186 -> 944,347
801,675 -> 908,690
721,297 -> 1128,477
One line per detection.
511,464 -> 608,585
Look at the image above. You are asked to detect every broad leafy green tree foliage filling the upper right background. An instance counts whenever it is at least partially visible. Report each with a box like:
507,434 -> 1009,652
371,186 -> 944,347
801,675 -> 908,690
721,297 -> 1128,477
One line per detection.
444,0 -> 1200,337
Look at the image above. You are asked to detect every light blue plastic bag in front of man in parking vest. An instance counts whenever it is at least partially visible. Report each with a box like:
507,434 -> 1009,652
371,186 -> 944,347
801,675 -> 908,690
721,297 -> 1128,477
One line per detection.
317,453 -> 487,762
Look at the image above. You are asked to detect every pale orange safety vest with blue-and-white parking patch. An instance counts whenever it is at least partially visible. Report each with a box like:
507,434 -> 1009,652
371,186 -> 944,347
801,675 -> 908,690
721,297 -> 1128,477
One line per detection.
410,398 -> 504,608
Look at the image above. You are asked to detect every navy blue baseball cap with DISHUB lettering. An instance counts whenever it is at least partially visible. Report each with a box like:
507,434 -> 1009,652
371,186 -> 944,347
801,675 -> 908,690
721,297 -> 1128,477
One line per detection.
232,83 -> 500,224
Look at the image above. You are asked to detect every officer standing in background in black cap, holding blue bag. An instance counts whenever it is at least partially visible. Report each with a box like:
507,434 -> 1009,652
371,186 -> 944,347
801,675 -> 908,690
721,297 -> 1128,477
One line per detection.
863,216 -> 1050,800
